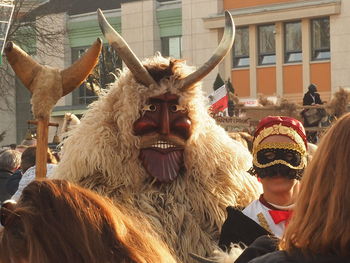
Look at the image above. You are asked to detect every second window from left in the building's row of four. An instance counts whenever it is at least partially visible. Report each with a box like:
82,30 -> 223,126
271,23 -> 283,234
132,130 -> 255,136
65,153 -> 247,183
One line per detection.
258,25 -> 276,65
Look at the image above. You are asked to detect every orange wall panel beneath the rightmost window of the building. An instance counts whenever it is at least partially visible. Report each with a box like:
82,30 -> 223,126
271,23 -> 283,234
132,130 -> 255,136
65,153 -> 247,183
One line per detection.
310,62 -> 331,91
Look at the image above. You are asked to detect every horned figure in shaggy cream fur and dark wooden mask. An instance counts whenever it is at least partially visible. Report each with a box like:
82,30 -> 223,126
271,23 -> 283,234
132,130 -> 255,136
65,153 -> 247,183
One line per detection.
55,9 -> 259,263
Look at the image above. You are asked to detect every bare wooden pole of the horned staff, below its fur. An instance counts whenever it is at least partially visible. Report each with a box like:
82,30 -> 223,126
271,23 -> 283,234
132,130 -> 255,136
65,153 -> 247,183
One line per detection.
35,118 -> 49,179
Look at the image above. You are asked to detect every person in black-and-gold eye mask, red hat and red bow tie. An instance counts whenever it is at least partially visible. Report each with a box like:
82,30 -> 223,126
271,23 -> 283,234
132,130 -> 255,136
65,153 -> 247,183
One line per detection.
219,116 -> 307,253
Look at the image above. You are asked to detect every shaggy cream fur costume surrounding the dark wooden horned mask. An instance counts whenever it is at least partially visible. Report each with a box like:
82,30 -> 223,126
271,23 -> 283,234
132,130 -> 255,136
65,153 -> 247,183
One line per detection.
54,9 -> 259,263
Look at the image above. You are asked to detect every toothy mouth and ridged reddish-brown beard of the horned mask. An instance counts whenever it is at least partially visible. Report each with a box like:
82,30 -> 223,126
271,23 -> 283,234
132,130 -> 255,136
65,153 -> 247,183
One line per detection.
139,138 -> 185,183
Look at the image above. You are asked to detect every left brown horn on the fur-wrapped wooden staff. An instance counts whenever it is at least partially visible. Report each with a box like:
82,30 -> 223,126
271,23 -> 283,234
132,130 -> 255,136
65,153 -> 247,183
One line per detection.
5,42 -> 43,93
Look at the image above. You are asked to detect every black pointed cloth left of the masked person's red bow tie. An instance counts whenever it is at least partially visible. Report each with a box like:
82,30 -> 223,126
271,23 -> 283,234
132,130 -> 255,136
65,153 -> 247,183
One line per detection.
219,206 -> 272,250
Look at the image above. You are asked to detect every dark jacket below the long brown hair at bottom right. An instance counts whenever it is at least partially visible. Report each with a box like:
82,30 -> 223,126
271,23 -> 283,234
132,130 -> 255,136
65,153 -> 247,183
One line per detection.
249,251 -> 350,263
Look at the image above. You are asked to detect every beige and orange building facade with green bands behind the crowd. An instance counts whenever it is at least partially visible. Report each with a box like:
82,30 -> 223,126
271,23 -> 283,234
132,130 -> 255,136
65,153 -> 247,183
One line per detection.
0,0 -> 350,143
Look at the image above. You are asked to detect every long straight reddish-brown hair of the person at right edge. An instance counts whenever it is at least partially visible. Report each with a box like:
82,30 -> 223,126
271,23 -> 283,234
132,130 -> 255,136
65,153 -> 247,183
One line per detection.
281,113 -> 350,257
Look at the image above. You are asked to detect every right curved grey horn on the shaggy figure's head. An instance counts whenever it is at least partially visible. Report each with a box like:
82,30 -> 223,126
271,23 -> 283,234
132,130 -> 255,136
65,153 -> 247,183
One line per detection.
182,11 -> 235,90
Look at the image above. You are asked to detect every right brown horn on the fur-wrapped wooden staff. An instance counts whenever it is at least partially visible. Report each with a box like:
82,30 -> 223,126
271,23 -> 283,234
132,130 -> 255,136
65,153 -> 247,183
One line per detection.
60,38 -> 102,96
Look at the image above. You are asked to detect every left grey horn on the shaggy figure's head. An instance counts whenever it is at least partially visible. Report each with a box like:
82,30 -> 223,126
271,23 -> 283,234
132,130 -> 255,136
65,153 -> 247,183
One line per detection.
97,9 -> 157,86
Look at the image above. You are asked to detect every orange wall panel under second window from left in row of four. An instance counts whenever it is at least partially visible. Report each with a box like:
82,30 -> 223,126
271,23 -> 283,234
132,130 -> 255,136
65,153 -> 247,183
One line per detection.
256,67 -> 276,96
